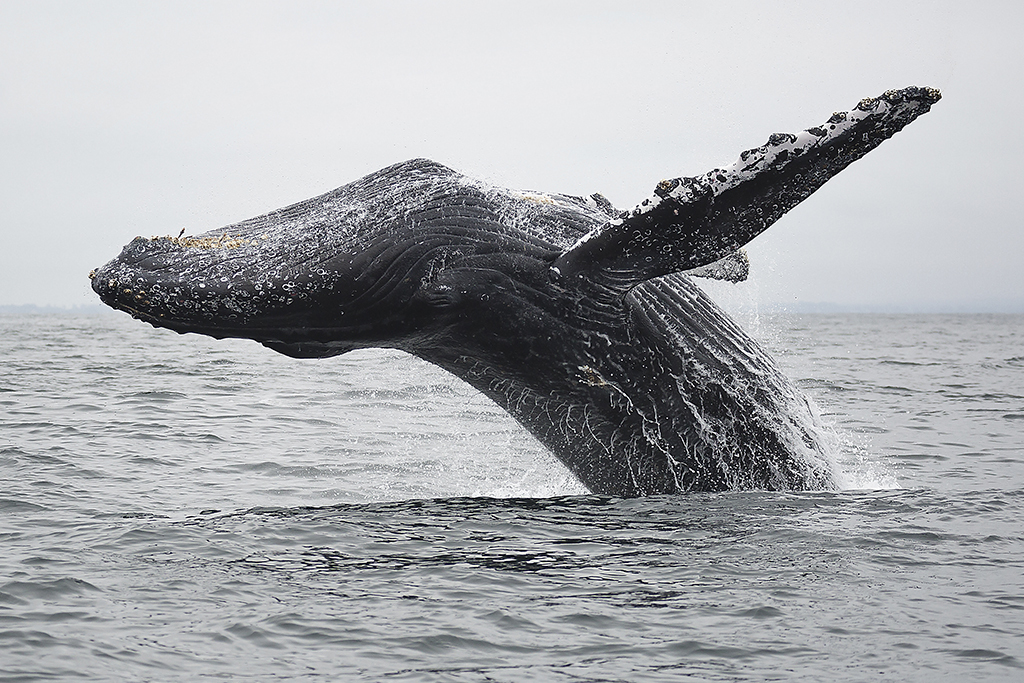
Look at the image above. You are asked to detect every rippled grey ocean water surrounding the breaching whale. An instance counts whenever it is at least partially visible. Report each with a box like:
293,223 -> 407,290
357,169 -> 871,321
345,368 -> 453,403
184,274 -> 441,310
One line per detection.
0,312 -> 1024,682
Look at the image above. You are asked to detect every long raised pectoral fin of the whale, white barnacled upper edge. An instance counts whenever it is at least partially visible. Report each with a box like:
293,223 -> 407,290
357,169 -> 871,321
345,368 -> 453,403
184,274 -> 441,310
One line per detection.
552,87 -> 940,292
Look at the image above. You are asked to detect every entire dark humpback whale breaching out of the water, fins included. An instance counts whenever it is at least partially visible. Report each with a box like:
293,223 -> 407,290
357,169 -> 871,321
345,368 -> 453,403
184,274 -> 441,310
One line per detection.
90,87 -> 940,497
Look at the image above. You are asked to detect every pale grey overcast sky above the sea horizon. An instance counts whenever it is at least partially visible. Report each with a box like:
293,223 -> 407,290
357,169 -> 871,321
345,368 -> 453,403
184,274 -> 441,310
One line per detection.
0,0 -> 1024,310
